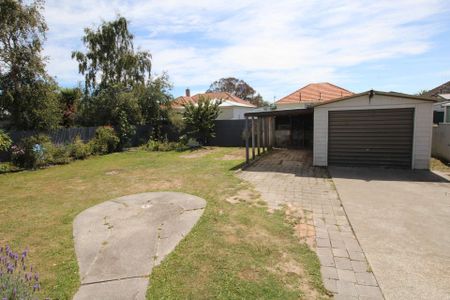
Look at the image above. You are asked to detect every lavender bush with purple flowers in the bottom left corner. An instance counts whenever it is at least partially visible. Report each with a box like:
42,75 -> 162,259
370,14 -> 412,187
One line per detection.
0,246 -> 41,299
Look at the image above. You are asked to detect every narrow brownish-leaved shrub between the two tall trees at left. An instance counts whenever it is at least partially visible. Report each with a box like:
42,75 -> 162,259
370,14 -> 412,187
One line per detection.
59,88 -> 83,127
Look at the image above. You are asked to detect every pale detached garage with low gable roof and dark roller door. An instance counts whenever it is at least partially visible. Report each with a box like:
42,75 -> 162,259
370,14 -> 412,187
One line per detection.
313,90 -> 434,169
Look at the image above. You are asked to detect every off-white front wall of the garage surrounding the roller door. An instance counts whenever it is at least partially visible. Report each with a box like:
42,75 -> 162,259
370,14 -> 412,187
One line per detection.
313,94 -> 433,169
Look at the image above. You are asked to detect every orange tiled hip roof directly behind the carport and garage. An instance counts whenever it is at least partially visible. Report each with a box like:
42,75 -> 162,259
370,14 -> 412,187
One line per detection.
275,82 -> 353,104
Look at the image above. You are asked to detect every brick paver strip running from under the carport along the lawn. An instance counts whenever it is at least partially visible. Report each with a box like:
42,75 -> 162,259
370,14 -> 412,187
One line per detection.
239,150 -> 383,299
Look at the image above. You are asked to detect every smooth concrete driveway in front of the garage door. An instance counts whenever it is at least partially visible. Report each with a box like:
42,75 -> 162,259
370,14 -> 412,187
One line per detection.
330,168 -> 450,299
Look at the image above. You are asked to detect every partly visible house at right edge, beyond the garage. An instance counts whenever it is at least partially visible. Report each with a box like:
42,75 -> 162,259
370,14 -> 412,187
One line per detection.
424,81 -> 450,124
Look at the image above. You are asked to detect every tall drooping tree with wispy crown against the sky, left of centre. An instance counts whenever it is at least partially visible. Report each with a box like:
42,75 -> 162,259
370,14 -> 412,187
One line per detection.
72,16 -> 151,93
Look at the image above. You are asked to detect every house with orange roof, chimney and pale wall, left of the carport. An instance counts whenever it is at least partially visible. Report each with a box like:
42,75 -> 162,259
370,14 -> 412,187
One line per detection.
171,89 -> 256,120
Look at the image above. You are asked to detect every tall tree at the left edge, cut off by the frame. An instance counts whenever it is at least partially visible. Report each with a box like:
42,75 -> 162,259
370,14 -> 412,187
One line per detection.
0,0 -> 61,130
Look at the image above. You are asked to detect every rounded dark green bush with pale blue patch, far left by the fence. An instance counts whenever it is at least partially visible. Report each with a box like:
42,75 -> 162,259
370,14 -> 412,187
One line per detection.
11,134 -> 53,169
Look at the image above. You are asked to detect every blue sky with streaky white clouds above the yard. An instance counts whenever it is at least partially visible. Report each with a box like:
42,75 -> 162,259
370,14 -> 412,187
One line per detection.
44,0 -> 450,102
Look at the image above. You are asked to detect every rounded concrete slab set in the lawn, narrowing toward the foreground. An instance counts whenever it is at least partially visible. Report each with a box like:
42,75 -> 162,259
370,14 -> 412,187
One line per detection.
73,192 -> 206,300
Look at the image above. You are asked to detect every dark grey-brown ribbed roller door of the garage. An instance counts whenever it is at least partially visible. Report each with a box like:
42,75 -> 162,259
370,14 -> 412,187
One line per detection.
328,108 -> 414,168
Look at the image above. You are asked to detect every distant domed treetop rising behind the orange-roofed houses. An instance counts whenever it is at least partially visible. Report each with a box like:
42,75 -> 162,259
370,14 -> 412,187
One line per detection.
206,77 -> 266,106
